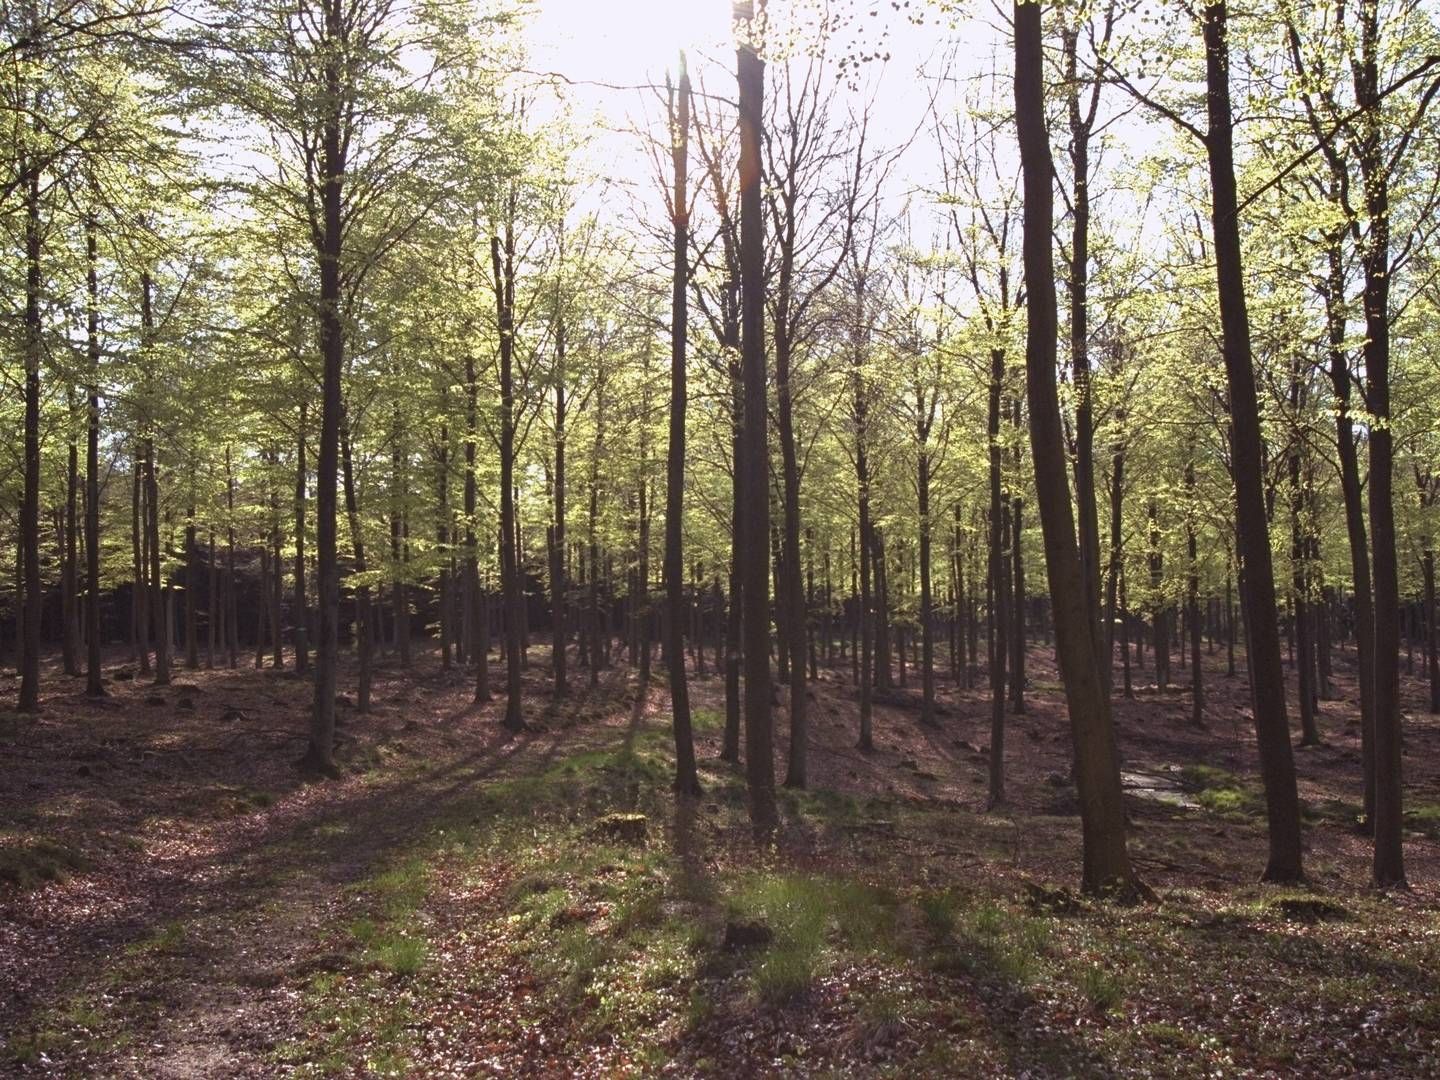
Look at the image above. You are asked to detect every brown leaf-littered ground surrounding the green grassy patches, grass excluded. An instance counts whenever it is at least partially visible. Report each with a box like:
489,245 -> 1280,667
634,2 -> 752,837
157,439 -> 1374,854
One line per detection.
0,645 -> 1440,1077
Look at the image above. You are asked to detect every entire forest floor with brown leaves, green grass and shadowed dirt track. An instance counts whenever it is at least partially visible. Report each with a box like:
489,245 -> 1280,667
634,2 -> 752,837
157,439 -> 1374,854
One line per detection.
0,645 -> 1440,1079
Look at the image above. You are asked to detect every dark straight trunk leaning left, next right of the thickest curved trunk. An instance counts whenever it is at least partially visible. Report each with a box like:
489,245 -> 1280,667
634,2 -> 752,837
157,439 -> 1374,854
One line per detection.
1202,0 -> 1305,881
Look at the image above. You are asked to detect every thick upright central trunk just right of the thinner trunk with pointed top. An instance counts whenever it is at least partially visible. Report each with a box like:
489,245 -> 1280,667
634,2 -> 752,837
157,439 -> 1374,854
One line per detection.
734,0 -> 779,832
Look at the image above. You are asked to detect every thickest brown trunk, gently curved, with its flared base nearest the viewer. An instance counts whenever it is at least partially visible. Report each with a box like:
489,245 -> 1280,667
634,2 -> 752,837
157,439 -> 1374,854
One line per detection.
1013,3 -> 1142,893
